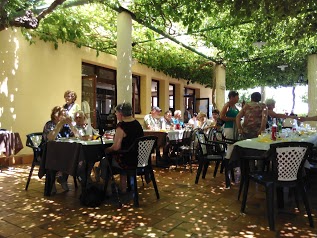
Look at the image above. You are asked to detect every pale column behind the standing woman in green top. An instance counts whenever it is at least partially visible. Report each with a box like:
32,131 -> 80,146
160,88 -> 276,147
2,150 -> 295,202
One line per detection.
215,64 -> 226,110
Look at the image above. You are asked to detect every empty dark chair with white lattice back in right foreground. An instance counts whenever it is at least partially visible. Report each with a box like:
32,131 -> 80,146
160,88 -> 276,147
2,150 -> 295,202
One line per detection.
241,142 -> 314,230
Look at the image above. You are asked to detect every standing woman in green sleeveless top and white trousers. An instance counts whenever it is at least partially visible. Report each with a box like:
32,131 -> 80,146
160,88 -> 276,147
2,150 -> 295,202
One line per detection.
220,91 -> 239,156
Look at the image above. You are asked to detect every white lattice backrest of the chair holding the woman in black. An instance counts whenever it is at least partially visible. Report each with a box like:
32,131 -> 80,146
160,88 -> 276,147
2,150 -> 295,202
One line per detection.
135,136 -> 157,167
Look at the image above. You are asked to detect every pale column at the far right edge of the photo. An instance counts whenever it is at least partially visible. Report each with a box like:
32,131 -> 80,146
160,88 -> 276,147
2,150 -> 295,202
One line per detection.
307,54 -> 317,116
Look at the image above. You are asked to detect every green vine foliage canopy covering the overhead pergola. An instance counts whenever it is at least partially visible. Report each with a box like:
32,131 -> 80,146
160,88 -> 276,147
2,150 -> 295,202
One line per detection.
0,0 -> 317,90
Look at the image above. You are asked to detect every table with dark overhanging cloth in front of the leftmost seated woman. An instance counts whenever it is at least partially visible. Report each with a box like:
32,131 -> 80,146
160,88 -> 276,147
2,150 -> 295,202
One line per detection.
39,138 -> 113,196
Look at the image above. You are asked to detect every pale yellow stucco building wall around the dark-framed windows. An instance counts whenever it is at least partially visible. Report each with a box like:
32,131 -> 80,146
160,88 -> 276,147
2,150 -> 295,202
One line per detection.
0,29 -> 211,154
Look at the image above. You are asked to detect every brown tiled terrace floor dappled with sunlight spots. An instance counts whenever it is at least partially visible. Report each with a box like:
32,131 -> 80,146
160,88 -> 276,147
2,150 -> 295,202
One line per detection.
0,165 -> 317,238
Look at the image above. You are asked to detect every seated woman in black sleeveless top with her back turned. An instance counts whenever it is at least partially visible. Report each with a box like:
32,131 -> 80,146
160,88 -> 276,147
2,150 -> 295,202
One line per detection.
105,103 -> 144,195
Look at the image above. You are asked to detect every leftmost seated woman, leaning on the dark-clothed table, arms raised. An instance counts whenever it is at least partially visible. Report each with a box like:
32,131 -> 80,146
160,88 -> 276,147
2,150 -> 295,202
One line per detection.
41,106 -> 79,193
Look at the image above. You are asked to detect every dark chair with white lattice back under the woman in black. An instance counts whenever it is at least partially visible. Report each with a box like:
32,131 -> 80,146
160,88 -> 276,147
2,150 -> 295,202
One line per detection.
104,136 -> 160,207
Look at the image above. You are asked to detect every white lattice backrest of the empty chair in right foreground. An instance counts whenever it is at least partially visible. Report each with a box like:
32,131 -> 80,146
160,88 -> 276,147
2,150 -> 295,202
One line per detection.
269,142 -> 313,181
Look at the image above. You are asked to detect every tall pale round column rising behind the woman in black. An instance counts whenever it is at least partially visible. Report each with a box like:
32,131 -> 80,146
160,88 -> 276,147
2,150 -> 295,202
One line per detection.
117,11 -> 132,104
